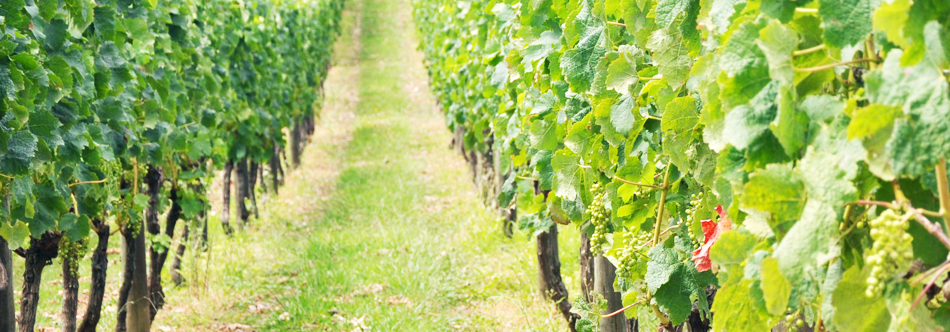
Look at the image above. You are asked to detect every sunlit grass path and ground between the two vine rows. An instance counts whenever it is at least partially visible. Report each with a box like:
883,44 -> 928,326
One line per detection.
22,0 -> 577,331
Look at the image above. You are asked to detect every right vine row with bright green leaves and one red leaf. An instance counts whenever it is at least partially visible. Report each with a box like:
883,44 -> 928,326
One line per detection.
414,0 -> 950,331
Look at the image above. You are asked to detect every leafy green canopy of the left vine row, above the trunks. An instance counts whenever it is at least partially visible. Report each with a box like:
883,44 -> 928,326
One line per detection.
0,0 -> 343,248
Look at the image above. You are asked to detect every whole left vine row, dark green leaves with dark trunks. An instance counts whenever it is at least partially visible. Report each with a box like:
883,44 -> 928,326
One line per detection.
0,0 -> 343,331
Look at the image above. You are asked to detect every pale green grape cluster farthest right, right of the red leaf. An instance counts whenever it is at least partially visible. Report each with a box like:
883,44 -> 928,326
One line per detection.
865,210 -> 914,297
